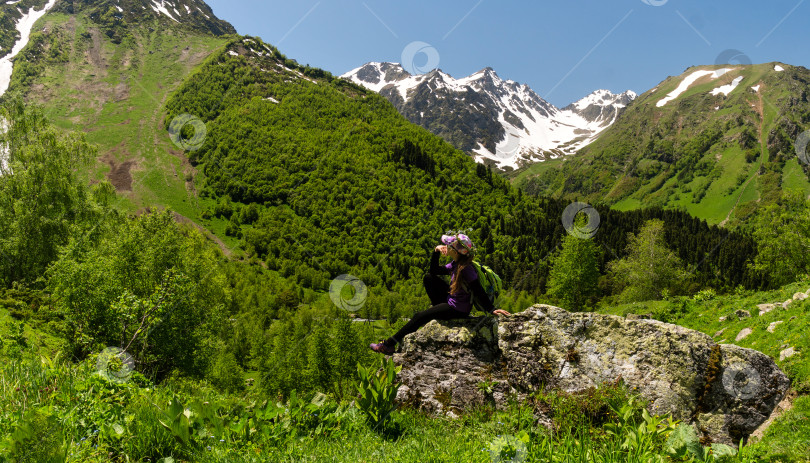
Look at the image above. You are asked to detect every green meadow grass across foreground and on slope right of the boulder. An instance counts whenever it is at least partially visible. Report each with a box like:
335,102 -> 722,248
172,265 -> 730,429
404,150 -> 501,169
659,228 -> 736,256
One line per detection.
6,281 -> 810,463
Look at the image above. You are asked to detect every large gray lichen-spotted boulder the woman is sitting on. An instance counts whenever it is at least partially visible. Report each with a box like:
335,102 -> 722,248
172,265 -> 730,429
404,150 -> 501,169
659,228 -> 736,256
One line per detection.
394,305 -> 789,444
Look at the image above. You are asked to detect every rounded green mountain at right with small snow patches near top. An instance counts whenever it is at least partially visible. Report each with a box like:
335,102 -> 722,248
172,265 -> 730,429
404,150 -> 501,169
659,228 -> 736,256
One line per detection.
514,63 -> 810,227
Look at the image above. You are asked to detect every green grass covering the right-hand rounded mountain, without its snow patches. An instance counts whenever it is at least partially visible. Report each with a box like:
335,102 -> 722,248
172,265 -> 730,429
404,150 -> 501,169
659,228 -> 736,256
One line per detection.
532,63 -> 810,226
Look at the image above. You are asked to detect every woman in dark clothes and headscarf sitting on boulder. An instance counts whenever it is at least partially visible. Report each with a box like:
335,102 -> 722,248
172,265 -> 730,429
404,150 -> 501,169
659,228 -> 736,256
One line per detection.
369,234 -> 510,355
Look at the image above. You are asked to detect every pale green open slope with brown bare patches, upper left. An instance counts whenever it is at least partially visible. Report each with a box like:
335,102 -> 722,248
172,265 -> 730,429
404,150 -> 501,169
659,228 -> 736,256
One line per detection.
4,2 -> 232,227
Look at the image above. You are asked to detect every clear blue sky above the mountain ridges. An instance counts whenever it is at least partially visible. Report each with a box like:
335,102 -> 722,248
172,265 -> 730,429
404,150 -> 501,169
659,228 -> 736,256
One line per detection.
207,0 -> 810,107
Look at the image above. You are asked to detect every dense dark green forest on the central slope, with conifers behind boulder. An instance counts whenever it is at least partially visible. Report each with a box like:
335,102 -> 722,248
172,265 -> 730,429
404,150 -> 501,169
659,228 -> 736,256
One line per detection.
161,38 -> 765,320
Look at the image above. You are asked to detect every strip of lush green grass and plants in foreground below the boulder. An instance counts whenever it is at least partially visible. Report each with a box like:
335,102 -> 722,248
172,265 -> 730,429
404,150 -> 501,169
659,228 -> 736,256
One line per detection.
0,346 -> 740,463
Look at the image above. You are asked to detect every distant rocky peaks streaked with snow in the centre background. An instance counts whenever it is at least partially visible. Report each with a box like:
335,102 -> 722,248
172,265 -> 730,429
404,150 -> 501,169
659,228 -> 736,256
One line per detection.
342,63 -> 637,168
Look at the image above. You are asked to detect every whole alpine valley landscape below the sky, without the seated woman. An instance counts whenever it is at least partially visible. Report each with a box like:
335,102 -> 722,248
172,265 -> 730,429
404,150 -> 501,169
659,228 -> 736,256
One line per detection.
0,0 -> 810,463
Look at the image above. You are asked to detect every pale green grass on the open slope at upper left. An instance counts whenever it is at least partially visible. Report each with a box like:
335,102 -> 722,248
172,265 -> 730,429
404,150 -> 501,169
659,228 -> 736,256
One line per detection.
22,14 -> 233,226
